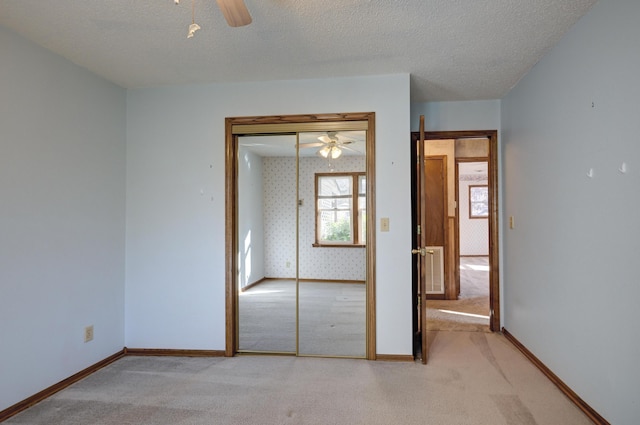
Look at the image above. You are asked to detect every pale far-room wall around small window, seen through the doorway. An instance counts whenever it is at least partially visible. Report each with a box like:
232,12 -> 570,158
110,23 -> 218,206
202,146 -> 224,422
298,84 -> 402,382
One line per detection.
458,175 -> 489,255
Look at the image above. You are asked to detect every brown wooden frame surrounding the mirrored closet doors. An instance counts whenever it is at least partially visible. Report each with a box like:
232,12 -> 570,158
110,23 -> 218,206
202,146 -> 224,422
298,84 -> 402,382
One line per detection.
225,112 -> 376,360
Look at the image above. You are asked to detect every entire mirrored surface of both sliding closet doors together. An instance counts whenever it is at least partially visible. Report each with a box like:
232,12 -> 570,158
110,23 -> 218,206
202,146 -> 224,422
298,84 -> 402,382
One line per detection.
237,127 -> 367,357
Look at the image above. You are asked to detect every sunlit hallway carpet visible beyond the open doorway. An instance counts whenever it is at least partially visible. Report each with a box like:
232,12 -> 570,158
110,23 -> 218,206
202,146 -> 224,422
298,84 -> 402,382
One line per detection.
427,257 -> 489,332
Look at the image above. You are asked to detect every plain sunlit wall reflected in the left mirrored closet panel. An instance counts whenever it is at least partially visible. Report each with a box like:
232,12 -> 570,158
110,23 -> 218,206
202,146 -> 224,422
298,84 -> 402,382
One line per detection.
238,146 -> 265,288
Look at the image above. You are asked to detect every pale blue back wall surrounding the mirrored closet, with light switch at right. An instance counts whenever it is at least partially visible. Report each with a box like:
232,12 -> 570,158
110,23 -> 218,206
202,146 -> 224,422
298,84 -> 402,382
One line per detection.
126,75 -> 412,354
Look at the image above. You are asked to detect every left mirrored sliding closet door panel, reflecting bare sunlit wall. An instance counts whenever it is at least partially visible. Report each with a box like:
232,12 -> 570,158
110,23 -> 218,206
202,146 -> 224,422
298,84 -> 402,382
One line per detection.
237,134 -> 297,353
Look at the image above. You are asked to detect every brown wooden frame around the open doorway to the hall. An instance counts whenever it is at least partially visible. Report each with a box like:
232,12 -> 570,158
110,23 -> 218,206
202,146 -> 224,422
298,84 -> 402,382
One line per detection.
411,130 -> 501,334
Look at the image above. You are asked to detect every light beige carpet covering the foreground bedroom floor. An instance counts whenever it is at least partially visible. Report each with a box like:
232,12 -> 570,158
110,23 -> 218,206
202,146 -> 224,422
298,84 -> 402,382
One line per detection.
5,332 -> 590,425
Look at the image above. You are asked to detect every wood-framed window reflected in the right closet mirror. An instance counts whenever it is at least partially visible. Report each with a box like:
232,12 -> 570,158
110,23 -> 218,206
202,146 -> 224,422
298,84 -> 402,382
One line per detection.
314,173 -> 367,247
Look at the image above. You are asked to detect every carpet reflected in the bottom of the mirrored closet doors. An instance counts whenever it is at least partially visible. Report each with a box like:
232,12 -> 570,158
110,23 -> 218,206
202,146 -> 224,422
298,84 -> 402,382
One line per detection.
238,279 -> 366,357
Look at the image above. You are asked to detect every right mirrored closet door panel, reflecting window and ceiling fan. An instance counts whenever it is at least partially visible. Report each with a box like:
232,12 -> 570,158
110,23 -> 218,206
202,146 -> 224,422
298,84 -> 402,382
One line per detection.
298,131 -> 367,357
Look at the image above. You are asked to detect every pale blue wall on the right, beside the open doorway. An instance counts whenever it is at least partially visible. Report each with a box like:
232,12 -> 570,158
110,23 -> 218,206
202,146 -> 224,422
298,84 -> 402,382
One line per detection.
502,0 -> 640,425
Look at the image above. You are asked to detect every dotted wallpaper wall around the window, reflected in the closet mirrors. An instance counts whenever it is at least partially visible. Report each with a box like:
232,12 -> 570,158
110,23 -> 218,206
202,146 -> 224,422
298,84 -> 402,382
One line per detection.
263,156 -> 366,280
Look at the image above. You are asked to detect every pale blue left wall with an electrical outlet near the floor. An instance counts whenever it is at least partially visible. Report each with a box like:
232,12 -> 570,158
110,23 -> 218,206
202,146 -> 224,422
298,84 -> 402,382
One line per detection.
0,27 -> 126,411
